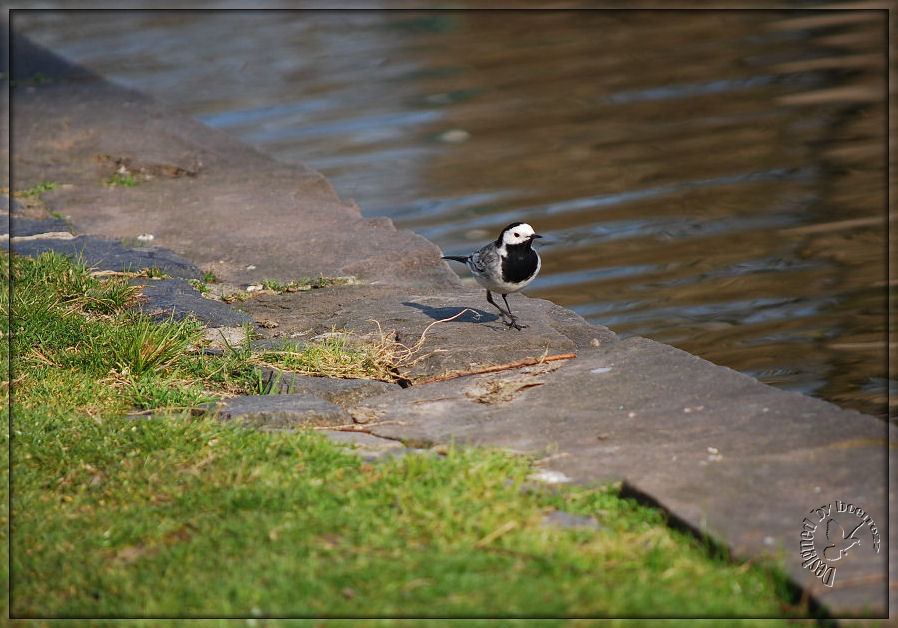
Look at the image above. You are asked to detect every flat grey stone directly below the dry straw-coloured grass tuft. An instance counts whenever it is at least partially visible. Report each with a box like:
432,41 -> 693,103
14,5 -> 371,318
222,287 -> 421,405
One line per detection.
260,367 -> 401,408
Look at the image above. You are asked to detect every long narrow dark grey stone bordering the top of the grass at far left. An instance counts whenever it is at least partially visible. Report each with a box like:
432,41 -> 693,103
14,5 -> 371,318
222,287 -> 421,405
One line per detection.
2,234 -> 203,279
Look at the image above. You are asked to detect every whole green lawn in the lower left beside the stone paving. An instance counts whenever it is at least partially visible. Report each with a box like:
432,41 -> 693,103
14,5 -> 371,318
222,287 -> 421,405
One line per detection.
0,254 -> 806,626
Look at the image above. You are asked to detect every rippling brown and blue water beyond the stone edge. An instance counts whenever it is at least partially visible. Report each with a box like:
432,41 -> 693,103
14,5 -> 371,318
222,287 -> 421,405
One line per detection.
13,4 -> 896,417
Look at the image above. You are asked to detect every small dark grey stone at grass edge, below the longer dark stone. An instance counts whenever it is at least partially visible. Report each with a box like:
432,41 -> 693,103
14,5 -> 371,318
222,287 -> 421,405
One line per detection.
131,279 -> 253,327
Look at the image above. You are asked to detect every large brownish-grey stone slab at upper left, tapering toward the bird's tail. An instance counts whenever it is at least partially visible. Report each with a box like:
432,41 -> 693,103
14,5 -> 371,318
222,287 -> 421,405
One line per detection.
11,36 -> 459,289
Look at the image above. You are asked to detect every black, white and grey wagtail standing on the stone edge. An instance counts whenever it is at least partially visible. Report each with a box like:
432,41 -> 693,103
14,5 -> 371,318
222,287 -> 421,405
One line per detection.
443,222 -> 542,329
